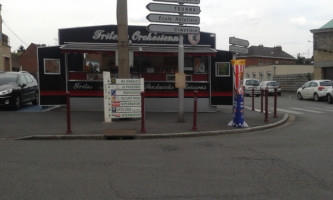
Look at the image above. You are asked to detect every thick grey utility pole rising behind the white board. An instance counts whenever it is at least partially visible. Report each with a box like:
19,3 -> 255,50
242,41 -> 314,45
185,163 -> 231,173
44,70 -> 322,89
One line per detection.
117,0 -> 131,78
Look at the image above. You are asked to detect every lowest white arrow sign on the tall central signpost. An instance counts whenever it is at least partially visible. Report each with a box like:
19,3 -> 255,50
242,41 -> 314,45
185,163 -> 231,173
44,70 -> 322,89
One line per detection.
147,24 -> 200,34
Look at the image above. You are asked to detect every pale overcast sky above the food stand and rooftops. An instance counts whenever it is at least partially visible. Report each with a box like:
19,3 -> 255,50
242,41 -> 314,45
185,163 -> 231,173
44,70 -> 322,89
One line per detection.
0,0 -> 333,57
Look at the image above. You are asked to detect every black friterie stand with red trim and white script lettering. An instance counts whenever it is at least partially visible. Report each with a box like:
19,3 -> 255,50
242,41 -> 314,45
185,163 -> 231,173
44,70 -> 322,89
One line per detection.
38,25 -> 233,112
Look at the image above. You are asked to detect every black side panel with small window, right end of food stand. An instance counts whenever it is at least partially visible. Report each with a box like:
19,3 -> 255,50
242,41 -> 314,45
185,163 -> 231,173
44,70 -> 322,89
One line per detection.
210,51 -> 233,105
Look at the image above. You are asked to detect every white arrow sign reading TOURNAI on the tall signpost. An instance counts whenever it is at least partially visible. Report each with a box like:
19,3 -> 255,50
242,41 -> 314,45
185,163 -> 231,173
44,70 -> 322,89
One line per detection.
147,3 -> 201,15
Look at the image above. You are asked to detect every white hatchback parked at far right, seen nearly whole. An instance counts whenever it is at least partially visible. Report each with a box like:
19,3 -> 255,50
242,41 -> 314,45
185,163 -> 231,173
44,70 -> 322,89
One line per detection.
297,80 -> 333,101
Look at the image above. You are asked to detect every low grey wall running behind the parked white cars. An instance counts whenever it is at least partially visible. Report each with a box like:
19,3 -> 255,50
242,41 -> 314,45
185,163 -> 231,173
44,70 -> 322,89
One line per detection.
273,73 -> 313,92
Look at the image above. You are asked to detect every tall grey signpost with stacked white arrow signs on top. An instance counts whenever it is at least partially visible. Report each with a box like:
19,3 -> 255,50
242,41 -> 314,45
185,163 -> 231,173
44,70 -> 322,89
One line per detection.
146,0 -> 201,122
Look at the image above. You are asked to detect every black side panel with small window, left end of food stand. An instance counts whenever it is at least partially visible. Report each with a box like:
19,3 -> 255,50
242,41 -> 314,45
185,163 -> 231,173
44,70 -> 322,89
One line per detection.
38,46 -> 67,105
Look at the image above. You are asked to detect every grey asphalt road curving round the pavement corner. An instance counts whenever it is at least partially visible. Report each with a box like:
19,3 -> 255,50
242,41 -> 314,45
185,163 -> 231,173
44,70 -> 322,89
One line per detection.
0,95 -> 333,200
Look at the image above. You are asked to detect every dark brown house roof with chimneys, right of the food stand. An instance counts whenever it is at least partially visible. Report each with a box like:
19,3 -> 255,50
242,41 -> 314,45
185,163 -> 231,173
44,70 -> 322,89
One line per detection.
237,45 -> 295,60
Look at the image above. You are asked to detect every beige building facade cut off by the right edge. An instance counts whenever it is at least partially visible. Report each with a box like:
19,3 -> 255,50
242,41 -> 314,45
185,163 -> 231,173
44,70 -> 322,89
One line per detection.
311,19 -> 333,80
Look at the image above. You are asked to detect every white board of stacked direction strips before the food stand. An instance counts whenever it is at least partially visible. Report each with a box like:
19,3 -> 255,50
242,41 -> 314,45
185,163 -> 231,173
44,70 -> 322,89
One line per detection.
104,72 -> 144,122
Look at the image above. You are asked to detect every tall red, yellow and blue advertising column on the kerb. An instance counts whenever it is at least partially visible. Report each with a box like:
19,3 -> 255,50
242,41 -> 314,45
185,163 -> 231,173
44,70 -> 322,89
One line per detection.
229,60 -> 248,128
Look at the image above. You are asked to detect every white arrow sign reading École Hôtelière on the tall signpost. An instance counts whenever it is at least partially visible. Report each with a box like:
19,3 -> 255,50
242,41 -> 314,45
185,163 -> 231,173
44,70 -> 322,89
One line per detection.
147,14 -> 200,24
